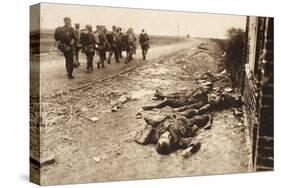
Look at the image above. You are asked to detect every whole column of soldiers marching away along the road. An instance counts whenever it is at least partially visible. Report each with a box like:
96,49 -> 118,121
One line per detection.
55,17 -> 150,79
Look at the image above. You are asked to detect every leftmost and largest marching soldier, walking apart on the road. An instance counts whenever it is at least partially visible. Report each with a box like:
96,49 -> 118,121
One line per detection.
55,17 -> 77,79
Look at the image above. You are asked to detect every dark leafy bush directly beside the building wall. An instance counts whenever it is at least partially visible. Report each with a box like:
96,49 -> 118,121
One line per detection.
224,28 -> 245,86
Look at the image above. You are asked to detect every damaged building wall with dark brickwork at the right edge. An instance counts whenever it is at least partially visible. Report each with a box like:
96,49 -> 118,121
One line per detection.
243,17 -> 273,171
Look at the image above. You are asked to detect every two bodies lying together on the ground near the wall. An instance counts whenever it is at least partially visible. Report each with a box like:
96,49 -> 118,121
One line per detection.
136,87 -> 241,154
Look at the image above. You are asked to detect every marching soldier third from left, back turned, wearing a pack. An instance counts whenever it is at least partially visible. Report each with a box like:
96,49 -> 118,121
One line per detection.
81,25 -> 95,73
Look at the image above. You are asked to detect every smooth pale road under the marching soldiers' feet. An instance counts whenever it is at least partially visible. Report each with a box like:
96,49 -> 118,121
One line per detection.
40,41 -> 191,96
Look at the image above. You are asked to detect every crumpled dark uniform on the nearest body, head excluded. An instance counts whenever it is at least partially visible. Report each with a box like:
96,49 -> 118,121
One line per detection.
135,113 -> 210,154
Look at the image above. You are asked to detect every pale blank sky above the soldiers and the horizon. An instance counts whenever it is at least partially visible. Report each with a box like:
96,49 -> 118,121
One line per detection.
31,3 -> 246,38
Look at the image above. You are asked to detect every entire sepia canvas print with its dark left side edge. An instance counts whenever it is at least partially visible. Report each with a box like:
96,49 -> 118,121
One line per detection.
29,3 -> 274,185
